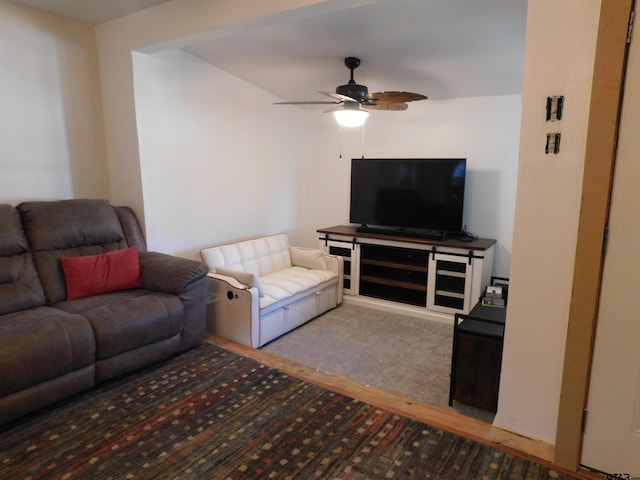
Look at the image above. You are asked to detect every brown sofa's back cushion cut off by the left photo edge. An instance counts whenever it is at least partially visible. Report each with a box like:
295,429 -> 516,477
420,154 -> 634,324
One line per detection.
0,205 -> 45,315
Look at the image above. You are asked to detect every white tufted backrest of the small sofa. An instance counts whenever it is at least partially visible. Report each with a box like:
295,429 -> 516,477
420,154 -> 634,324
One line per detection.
200,233 -> 291,277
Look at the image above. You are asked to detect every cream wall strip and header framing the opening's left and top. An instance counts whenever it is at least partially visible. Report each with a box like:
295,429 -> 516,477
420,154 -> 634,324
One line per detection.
95,0 -> 335,219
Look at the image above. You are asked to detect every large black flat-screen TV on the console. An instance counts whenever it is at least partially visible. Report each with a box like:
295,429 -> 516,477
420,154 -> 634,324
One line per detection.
349,158 -> 466,233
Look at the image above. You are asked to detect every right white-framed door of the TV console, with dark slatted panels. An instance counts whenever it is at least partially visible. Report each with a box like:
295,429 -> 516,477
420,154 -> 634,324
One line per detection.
427,253 -> 474,313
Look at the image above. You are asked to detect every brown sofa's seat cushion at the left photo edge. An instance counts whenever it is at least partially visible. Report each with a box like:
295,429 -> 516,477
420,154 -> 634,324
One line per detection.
0,307 -> 95,397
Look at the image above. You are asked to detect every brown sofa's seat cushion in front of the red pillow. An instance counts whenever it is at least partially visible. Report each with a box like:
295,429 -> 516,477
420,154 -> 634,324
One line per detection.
54,289 -> 184,360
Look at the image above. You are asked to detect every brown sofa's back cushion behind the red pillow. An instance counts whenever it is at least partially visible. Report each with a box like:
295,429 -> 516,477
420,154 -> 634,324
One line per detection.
17,199 -> 128,303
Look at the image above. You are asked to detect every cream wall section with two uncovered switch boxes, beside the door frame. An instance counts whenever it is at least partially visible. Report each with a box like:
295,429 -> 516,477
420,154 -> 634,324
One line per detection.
494,0 -> 600,443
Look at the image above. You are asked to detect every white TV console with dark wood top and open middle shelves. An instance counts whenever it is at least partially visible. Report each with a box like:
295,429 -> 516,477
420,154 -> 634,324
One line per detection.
318,225 -> 496,324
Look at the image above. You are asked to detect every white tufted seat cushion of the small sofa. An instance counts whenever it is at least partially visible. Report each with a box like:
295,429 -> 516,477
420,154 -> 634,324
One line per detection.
260,267 -> 338,309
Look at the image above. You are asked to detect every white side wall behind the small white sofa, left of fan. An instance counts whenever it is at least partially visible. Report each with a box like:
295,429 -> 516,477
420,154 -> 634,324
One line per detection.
133,49 -> 304,258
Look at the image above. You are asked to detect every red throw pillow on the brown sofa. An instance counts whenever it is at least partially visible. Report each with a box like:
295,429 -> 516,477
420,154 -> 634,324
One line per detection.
61,247 -> 140,300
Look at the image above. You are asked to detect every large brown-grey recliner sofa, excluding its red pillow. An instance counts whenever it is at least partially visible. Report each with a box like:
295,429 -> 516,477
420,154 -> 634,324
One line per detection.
0,199 -> 208,424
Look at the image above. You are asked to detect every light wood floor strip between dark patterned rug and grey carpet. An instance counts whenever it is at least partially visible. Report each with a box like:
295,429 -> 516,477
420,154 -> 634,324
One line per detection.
207,334 -> 604,480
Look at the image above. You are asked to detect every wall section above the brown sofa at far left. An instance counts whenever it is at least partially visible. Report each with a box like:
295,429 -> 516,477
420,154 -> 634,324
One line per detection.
0,0 -> 109,204
